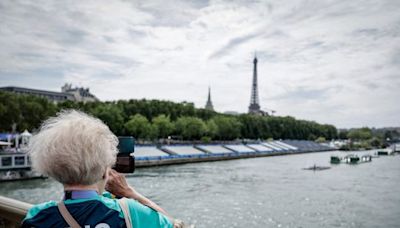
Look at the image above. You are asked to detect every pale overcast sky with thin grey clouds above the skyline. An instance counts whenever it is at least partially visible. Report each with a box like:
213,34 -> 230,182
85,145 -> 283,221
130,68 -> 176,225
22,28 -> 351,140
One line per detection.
0,0 -> 400,128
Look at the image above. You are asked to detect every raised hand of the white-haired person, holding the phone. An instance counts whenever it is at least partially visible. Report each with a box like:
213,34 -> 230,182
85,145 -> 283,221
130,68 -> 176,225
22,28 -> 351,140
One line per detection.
106,169 -> 135,198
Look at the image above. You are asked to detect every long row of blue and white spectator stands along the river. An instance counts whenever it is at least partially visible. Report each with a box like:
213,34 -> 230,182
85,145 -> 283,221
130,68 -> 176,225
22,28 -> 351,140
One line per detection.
134,140 -> 334,167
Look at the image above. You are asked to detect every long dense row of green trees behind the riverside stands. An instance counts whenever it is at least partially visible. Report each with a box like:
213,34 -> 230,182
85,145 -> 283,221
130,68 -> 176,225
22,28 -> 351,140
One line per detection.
0,92 -> 338,141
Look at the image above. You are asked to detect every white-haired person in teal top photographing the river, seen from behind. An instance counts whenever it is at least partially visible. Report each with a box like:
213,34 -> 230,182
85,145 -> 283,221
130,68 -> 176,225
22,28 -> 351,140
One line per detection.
22,111 -> 177,228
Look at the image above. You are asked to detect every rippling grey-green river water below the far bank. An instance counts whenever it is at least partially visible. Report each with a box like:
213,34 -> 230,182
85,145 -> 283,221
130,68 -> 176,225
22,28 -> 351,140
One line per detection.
0,152 -> 400,228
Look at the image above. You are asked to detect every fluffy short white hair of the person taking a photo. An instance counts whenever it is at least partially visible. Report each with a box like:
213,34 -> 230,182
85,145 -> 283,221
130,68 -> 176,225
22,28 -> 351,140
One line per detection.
29,110 -> 118,185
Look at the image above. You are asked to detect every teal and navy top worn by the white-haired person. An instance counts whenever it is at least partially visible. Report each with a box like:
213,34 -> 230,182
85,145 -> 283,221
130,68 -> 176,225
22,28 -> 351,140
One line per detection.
22,193 -> 173,228
